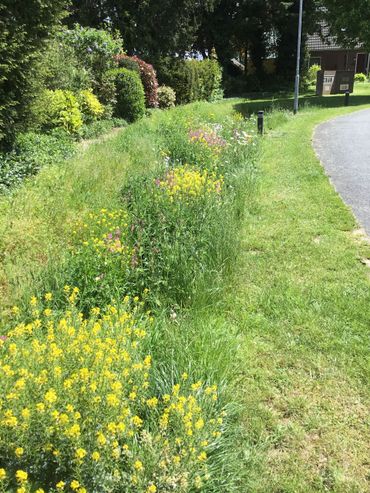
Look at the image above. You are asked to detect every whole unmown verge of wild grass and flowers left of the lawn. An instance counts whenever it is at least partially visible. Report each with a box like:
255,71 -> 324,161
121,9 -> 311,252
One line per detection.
0,104 -> 264,493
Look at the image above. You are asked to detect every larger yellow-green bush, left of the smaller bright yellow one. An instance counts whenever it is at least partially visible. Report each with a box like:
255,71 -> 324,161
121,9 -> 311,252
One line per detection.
45,89 -> 83,133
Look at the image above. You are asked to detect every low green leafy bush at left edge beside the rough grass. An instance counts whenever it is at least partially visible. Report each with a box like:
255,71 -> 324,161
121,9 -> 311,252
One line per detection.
0,130 -> 75,193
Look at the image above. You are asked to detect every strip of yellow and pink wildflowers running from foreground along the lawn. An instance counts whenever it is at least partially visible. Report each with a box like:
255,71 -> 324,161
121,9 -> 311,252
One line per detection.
0,104 -> 256,493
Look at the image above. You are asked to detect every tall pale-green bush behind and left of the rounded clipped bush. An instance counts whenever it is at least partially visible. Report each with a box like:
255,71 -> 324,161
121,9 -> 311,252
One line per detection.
59,24 -> 123,103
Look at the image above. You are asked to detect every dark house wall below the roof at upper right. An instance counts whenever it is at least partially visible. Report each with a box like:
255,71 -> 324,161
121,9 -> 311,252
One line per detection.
310,50 -> 368,72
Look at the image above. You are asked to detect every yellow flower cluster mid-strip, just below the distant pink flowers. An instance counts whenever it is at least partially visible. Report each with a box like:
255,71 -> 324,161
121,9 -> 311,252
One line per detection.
156,165 -> 223,199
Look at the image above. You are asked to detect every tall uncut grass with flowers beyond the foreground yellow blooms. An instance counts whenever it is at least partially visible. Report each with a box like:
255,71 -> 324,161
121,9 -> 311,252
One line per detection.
1,98 -> 264,493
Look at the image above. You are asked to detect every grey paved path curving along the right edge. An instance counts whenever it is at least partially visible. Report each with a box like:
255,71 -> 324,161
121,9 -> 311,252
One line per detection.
313,109 -> 370,235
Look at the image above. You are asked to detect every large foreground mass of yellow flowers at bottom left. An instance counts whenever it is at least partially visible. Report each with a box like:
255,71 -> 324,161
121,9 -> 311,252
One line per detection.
0,298 -> 222,493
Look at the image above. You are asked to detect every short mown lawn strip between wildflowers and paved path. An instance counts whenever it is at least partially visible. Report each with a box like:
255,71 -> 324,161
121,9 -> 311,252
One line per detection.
229,102 -> 370,493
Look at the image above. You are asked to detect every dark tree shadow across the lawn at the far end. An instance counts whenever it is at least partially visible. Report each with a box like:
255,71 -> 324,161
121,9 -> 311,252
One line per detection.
234,94 -> 370,116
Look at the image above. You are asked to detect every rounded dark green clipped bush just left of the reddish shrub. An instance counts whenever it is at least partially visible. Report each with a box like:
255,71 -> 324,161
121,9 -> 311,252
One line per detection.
110,68 -> 145,122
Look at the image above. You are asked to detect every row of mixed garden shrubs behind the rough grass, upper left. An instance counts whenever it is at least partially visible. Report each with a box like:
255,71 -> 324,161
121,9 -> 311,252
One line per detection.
0,17 -> 222,194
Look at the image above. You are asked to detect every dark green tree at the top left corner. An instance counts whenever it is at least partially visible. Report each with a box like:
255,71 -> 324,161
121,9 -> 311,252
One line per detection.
0,0 -> 67,146
